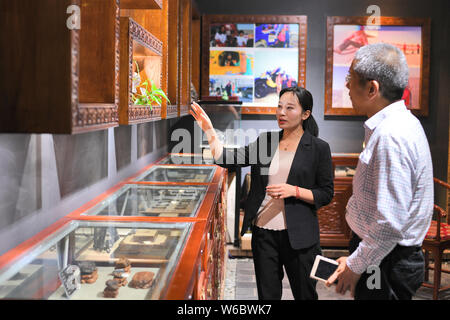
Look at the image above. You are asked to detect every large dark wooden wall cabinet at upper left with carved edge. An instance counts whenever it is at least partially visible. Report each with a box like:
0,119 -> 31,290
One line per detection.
0,0 -> 119,134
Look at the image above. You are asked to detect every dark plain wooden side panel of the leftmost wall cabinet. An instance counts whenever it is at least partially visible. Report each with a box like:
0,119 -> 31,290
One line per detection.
0,0 -> 76,133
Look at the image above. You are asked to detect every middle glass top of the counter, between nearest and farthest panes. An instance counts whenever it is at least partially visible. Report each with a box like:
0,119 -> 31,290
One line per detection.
82,184 -> 207,217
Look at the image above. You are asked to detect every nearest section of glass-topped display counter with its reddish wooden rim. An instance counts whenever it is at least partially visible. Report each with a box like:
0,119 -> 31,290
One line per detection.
0,220 -> 200,300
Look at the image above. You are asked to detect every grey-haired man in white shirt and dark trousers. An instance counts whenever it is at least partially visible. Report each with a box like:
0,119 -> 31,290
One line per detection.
327,43 -> 433,300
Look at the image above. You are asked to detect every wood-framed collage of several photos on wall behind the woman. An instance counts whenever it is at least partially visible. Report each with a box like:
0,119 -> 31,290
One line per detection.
201,15 -> 307,114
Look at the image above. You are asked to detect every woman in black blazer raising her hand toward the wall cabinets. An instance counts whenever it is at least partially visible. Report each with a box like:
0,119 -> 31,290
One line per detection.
191,87 -> 333,300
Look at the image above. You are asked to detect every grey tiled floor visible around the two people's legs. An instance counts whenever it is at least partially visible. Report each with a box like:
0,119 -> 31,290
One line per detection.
224,252 -> 450,300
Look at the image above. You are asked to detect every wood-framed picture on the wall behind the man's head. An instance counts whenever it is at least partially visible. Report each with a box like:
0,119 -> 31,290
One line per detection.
324,17 -> 430,116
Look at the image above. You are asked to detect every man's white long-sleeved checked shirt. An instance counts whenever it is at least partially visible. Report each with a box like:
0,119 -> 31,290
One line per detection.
346,100 -> 434,274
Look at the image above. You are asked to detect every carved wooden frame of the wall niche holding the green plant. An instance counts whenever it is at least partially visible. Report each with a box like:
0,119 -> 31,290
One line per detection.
119,17 -> 163,125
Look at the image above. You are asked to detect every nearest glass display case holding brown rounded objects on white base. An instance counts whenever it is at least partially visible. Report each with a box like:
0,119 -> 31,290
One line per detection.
0,221 -> 193,300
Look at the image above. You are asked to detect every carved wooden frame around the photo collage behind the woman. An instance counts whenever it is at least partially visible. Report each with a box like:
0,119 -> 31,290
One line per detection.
201,15 -> 307,114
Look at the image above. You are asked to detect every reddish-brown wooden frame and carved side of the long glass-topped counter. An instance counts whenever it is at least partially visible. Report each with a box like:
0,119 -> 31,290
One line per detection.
63,159 -> 228,300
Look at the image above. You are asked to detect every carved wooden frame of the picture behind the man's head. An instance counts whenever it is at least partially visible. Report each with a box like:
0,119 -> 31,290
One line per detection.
324,16 -> 431,116
